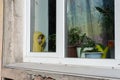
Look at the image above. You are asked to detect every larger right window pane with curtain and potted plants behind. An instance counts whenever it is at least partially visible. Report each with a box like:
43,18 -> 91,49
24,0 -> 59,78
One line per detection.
66,0 -> 115,59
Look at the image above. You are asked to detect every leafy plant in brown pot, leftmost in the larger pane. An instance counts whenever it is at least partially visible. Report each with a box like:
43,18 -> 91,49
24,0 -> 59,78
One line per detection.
67,27 -> 81,57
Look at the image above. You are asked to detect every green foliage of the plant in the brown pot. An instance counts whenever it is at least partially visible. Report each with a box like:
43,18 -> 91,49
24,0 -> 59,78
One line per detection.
68,27 -> 81,46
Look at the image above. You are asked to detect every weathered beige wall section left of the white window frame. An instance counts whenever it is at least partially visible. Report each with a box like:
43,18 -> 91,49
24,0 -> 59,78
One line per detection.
3,0 -> 25,64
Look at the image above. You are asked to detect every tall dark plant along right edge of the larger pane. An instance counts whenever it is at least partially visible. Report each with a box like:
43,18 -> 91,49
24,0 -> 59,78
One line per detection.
95,7 -> 114,40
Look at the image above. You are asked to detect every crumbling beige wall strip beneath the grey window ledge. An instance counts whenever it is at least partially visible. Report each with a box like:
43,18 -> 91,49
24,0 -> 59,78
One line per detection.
2,68 -> 103,80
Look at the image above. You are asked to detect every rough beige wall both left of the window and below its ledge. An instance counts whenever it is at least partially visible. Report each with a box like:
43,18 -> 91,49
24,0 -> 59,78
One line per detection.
2,0 -> 114,80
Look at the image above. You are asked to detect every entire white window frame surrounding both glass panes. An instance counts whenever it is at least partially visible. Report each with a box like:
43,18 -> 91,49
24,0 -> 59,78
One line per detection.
23,0 -> 120,69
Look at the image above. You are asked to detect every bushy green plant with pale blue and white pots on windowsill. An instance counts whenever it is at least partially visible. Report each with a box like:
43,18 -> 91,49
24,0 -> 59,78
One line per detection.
77,34 -> 103,58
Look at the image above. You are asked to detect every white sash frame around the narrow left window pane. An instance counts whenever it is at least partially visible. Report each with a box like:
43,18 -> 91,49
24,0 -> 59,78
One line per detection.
26,0 -> 65,57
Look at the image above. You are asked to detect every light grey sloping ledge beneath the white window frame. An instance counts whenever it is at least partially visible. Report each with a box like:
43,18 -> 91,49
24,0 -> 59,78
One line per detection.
5,63 -> 120,79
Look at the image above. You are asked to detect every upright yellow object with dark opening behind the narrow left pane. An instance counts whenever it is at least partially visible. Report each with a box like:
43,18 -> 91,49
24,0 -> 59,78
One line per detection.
33,32 -> 45,52
